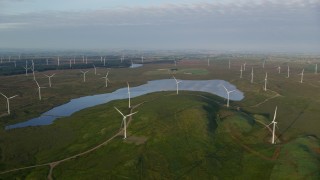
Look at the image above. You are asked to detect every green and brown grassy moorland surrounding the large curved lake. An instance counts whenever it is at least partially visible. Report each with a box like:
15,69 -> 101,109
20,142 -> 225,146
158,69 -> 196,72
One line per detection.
0,56 -> 320,179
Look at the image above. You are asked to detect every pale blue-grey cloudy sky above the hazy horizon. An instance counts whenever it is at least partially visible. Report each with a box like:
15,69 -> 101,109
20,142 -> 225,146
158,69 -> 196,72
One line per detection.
0,0 -> 320,53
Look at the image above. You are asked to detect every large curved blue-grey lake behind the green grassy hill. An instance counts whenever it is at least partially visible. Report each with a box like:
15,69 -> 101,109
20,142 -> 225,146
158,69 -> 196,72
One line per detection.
5,79 -> 244,129
